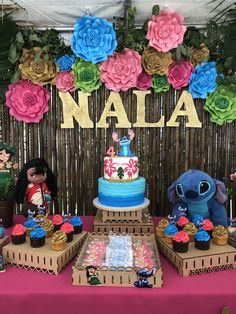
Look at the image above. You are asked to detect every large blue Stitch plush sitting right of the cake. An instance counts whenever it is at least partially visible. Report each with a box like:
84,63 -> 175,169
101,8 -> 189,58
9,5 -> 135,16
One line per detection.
168,170 -> 227,226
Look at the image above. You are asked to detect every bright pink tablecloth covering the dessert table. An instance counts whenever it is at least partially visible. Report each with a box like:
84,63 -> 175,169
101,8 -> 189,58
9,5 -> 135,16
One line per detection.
0,216 -> 236,314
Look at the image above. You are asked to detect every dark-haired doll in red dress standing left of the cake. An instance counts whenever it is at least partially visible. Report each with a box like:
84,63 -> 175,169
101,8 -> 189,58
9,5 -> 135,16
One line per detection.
15,158 -> 57,217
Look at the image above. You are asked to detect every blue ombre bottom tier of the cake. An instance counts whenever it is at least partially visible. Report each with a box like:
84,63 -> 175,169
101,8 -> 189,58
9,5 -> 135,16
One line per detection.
98,177 -> 145,207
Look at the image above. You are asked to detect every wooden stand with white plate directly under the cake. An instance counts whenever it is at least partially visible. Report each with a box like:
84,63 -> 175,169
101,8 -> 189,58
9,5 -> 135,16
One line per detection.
93,198 -> 154,234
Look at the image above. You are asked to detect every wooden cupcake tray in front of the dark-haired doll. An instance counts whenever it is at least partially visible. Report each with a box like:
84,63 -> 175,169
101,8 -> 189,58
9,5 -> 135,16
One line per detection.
3,232 -> 87,275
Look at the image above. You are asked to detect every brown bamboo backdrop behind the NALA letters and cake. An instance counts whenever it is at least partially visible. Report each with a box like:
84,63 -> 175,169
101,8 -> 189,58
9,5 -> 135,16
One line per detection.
0,87 -> 236,216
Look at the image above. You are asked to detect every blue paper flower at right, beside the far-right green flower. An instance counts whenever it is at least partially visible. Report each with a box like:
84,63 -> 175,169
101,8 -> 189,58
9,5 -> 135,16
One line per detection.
189,62 -> 217,99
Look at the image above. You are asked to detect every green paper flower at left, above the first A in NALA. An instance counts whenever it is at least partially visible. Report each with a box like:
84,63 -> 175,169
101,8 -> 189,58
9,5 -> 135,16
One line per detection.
72,61 -> 102,93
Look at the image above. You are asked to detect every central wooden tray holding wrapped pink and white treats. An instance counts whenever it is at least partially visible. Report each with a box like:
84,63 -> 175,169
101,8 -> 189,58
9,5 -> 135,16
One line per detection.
72,233 -> 163,288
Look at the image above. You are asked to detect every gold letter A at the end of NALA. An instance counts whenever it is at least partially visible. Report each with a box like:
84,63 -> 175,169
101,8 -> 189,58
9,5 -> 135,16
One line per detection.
166,91 -> 202,128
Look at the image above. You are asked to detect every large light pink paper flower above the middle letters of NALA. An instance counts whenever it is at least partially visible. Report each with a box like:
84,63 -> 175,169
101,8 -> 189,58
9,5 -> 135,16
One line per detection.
100,48 -> 142,92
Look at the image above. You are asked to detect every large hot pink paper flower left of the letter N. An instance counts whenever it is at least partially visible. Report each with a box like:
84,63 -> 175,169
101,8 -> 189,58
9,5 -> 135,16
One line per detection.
6,81 -> 51,123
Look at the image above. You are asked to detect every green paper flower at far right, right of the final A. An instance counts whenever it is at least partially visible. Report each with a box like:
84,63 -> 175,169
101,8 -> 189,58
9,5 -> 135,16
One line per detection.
204,84 -> 236,125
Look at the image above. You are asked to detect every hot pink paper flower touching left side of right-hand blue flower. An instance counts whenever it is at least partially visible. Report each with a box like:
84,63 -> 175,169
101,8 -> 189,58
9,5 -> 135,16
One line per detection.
168,61 -> 194,89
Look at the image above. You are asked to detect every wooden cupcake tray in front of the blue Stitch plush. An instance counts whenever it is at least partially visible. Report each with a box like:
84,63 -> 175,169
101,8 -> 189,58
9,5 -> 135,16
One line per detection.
157,237 -> 236,277
